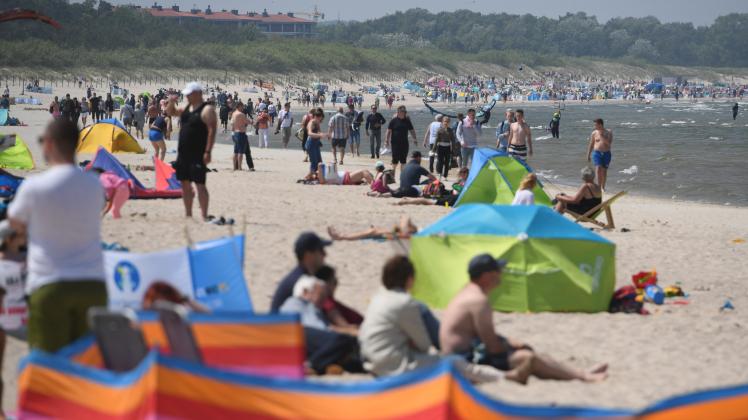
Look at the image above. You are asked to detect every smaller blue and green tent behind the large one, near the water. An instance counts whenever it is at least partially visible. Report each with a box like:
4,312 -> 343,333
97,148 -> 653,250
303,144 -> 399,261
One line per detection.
455,148 -> 551,207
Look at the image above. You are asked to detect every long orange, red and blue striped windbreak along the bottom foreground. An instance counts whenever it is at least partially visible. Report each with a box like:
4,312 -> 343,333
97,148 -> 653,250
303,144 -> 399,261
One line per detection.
18,351 -> 748,420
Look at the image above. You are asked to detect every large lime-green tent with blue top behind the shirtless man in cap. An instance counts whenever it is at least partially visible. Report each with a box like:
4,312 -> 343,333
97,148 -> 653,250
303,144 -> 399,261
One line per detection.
410,204 -> 616,312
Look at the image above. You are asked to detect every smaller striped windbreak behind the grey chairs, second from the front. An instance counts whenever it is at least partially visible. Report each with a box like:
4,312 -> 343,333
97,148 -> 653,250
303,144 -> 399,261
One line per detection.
58,311 -> 305,378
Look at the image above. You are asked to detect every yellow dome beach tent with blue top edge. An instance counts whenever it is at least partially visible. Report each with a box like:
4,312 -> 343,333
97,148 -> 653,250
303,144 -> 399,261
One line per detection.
77,118 -> 145,153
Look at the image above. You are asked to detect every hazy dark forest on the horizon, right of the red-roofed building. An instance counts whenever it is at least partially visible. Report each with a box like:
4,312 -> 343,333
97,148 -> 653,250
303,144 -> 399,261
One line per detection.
319,9 -> 748,67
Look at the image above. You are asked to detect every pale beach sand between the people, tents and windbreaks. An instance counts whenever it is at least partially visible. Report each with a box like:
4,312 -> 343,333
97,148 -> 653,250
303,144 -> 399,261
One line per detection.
0,87 -> 748,411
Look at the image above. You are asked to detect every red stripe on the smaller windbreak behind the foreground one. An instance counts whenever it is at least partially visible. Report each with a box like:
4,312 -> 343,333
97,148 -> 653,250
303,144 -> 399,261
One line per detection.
201,347 -> 305,366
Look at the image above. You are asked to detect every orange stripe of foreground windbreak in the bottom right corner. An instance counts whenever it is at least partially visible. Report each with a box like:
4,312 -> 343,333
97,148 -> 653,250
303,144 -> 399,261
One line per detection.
641,395 -> 748,420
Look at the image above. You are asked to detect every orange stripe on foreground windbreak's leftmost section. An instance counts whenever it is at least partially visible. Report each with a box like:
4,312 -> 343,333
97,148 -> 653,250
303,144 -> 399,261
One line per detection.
18,365 -> 156,416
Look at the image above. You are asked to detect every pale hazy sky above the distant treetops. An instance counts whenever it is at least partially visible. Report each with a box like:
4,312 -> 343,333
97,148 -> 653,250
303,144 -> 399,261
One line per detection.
109,0 -> 748,25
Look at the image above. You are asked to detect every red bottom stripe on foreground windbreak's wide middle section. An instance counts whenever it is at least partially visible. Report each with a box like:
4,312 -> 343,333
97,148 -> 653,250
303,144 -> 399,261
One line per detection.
158,393 -> 450,420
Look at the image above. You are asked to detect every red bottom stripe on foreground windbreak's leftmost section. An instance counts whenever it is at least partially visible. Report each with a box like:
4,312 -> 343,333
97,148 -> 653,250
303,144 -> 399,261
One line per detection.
18,391 -> 156,420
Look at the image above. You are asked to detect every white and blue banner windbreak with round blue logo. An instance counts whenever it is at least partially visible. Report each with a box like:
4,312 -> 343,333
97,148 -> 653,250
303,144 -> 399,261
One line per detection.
104,235 -> 252,312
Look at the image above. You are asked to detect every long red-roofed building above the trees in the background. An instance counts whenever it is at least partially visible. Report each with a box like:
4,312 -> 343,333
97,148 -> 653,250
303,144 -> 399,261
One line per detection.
145,4 -> 316,37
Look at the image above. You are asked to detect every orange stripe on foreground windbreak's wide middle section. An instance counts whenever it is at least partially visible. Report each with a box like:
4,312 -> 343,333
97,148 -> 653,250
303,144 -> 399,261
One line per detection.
158,366 -> 452,419
